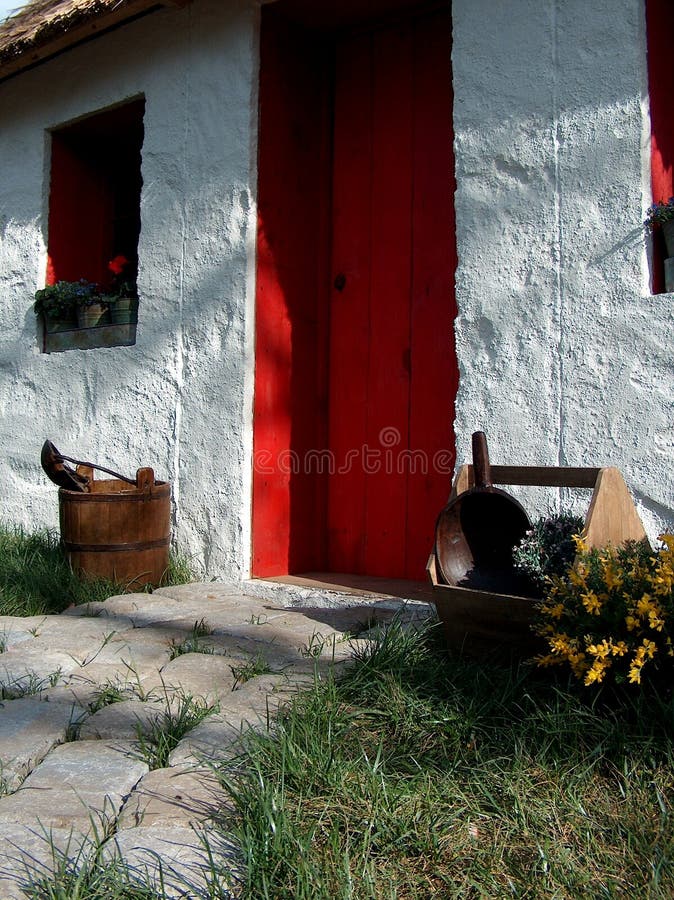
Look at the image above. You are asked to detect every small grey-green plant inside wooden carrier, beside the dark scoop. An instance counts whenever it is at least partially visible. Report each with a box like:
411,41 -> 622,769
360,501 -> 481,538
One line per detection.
513,512 -> 584,596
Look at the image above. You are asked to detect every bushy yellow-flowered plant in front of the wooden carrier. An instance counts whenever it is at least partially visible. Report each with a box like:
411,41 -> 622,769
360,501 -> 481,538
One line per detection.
535,534 -> 674,685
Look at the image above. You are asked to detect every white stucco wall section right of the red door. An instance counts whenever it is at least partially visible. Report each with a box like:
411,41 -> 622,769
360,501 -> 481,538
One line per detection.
452,0 -> 674,537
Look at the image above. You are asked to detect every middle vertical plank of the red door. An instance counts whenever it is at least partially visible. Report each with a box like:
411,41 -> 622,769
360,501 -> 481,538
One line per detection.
365,25 -> 413,575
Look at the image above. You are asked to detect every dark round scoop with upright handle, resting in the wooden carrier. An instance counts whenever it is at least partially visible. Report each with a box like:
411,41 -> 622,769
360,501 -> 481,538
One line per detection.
435,431 -> 531,594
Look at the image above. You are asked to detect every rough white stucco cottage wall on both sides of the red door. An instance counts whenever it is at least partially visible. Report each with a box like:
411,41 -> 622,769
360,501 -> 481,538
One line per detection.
0,0 -> 674,578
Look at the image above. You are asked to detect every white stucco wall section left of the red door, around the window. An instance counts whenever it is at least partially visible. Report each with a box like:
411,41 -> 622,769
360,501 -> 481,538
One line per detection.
0,0 -> 258,578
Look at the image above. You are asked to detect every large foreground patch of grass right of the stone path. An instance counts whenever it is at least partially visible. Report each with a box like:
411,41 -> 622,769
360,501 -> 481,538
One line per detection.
214,625 -> 674,900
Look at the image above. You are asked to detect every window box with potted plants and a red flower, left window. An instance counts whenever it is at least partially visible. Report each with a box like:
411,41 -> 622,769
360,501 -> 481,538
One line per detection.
33,256 -> 138,353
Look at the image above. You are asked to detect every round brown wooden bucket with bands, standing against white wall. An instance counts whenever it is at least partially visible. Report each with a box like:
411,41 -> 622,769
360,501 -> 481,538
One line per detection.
59,466 -> 171,590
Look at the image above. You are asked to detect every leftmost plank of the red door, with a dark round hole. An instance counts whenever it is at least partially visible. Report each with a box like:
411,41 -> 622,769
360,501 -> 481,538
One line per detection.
328,34 -> 372,572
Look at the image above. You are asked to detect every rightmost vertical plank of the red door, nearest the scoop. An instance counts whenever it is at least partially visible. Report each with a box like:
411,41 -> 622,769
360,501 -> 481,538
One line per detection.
405,12 -> 459,578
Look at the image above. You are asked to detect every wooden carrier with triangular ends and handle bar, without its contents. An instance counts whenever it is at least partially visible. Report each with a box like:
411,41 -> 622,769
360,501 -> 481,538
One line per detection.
427,465 -> 647,657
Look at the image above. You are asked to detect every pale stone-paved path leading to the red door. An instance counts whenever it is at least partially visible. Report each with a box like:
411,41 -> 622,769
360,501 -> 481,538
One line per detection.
0,584 -> 428,900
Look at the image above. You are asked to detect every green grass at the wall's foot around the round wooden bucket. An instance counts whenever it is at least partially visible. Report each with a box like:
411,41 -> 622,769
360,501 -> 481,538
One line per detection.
0,524 -> 194,616
